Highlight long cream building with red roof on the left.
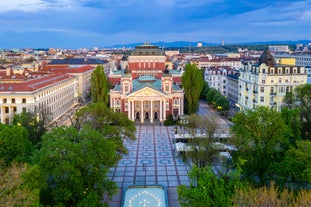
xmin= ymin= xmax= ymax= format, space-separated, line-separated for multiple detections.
xmin=0 ymin=74 xmax=78 ymax=124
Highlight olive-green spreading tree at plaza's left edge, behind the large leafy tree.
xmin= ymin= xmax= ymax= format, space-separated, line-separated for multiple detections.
xmin=76 ymin=103 xmax=136 ymax=154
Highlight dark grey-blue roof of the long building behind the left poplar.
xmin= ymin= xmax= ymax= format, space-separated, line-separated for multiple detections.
xmin=48 ymin=58 xmax=107 ymax=65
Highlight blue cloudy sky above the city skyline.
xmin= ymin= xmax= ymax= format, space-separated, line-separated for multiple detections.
xmin=0 ymin=0 xmax=311 ymax=48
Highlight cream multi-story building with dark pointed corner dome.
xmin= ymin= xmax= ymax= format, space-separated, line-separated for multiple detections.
xmin=238 ymin=49 xmax=307 ymax=111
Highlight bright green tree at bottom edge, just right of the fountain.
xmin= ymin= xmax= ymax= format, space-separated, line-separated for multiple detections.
xmin=177 ymin=166 xmax=239 ymax=207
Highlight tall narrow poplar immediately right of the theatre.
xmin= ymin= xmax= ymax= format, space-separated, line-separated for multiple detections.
xmin=181 ymin=64 xmax=204 ymax=114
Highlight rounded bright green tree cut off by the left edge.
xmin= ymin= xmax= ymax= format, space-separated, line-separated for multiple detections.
xmin=0 ymin=124 xmax=33 ymax=165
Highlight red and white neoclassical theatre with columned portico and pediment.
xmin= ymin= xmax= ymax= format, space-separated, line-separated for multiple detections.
xmin=108 ymin=43 xmax=184 ymax=123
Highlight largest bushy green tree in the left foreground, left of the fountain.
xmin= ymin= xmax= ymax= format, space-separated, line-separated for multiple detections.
xmin=25 ymin=127 xmax=120 ymax=207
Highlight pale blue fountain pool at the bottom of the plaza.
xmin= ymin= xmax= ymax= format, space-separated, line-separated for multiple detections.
xmin=121 ymin=185 xmax=168 ymax=207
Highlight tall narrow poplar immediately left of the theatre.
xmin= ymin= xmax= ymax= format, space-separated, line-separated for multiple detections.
xmin=91 ymin=65 xmax=110 ymax=106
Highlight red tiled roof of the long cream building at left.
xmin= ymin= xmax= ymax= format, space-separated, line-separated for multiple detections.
xmin=0 ymin=74 xmax=72 ymax=93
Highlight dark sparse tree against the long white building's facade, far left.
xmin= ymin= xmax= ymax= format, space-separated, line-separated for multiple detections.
xmin=13 ymin=112 xmax=46 ymax=145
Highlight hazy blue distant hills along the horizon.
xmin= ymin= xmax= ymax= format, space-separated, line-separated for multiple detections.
xmin=106 ymin=40 xmax=311 ymax=48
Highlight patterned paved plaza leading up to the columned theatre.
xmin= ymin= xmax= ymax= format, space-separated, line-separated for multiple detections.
xmin=109 ymin=125 xmax=189 ymax=207
